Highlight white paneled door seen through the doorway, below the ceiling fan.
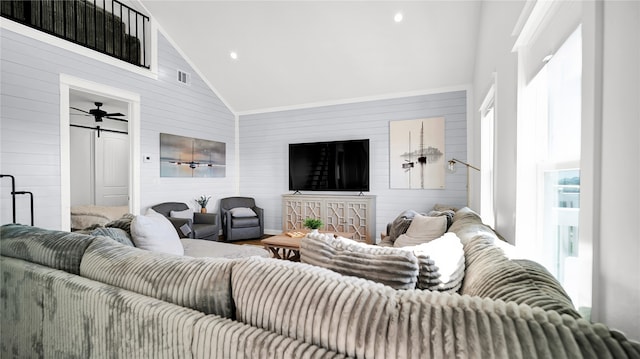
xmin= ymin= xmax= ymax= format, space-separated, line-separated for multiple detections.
xmin=95 ymin=132 xmax=130 ymax=206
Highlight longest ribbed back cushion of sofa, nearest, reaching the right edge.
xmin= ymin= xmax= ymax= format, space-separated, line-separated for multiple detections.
xmin=232 ymin=258 xmax=640 ymax=359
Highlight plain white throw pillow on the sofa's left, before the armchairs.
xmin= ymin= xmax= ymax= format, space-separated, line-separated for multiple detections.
xmin=131 ymin=209 xmax=184 ymax=256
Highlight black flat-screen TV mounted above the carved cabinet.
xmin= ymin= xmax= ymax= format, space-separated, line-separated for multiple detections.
xmin=289 ymin=139 xmax=369 ymax=192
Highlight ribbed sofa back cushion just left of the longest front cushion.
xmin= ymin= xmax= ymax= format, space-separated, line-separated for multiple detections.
xmin=80 ymin=237 xmax=234 ymax=318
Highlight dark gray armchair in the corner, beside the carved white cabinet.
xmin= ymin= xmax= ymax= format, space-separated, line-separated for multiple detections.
xmin=220 ymin=197 xmax=264 ymax=241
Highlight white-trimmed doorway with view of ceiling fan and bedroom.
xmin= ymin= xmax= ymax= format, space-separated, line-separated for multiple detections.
xmin=60 ymin=75 xmax=140 ymax=230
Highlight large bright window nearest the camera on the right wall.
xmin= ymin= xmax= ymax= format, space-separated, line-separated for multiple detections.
xmin=516 ymin=27 xmax=591 ymax=316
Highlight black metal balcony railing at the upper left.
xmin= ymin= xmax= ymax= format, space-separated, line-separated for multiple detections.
xmin=0 ymin=0 xmax=149 ymax=68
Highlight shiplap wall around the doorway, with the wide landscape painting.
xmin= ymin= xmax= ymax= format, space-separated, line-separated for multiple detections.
xmin=0 ymin=28 xmax=236 ymax=229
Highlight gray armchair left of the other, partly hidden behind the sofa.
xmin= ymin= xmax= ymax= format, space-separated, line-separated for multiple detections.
xmin=151 ymin=202 xmax=220 ymax=241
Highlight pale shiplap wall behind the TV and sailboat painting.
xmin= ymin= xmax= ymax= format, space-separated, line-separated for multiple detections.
xmin=239 ymin=91 xmax=467 ymax=237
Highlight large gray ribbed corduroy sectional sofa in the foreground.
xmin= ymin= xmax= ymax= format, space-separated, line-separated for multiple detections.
xmin=0 ymin=210 xmax=640 ymax=358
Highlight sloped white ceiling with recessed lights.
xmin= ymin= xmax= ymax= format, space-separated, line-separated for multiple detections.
xmin=141 ymin=0 xmax=482 ymax=113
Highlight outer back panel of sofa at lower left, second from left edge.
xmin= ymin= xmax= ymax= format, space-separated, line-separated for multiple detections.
xmin=42 ymin=271 xmax=204 ymax=359
